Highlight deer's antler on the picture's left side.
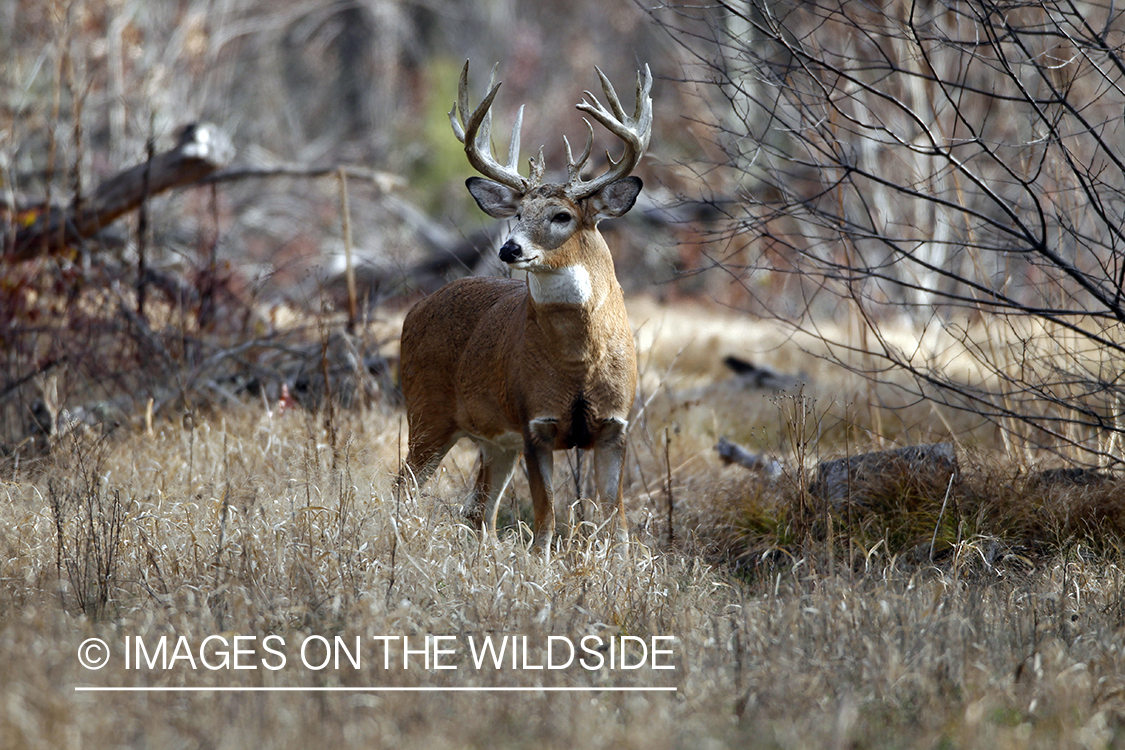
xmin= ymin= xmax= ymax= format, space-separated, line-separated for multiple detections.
xmin=449 ymin=61 xmax=543 ymax=193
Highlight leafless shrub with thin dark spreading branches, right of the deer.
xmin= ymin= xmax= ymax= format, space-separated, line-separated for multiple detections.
xmin=654 ymin=0 xmax=1125 ymax=467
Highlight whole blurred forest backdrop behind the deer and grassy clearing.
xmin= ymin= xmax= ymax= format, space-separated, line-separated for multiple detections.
xmin=0 ymin=0 xmax=1125 ymax=467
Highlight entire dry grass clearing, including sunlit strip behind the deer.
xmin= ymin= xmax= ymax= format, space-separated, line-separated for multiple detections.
xmin=0 ymin=306 xmax=1125 ymax=748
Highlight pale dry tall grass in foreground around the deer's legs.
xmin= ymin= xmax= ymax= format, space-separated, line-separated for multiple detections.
xmin=0 ymin=375 xmax=1125 ymax=748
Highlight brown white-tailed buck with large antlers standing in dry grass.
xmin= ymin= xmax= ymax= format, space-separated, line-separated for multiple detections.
xmin=398 ymin=62 xmax=653 ymax=554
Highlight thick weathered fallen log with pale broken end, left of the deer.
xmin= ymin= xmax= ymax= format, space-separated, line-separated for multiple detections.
xmin=3 ymin=123 xmax=234 ymax=262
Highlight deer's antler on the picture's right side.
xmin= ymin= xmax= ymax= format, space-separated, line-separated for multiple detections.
xmin=567 ymin=65 xmax=653 ymax=200
